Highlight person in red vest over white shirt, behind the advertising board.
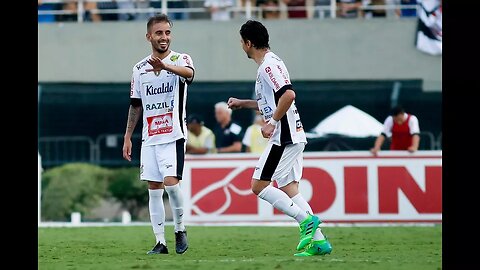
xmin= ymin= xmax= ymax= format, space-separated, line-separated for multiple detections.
xmin=370 ymin=106 xmax=420 ymax=155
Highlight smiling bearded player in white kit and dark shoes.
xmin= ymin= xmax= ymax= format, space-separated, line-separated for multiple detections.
xmin=123 ymin=14 xmax=194 ymax=254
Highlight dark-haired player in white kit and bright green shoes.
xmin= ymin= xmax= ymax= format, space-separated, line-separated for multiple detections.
xmin=228 ymin=20 xmax=332 ymax=256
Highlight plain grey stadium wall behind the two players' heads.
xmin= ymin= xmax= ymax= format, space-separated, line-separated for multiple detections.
xmin=38 ymin=19 xmax=442 ymax=91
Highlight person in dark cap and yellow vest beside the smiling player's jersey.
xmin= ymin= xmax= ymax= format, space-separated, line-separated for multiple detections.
xmin=187 ymin=114 xmax=216 ymax=154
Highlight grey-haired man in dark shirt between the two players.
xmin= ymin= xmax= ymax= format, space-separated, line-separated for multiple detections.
xmin=213 ymin=101 xmax=242 ymax=153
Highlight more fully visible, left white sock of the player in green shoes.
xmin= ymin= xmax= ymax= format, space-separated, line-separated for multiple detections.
xmin=258 ymin=185 xmax=307 ymax=223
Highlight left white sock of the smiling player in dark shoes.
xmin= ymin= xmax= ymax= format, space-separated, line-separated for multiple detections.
xmin=148 ymin=189 xmax=167 ymax=245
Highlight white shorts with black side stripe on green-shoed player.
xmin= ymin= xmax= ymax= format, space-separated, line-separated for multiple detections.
xmin=253 ymin=143 xmax=305 ymax=188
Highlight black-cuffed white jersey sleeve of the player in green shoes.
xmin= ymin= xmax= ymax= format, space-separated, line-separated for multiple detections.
xmin=260 ymin=64 xmax=293 ymax=99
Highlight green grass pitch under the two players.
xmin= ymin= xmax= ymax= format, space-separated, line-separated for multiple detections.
xmin=38 ymin=225 xmax=442 ymax=270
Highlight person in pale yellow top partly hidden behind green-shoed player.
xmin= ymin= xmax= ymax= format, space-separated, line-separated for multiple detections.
xmin=242 ymin=113 xmax=268 ymax=154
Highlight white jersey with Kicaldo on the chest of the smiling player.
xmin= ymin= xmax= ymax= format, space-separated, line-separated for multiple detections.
xmin=130 ymin=51 xmax=194 ymax=146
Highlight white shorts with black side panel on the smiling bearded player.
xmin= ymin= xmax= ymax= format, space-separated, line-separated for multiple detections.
xmin=140 ymin=139 xmax=186 ymax=183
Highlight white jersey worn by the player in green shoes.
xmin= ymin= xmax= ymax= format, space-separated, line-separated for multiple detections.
xmin=255 ymin=52 xmax=307 ymax=145
